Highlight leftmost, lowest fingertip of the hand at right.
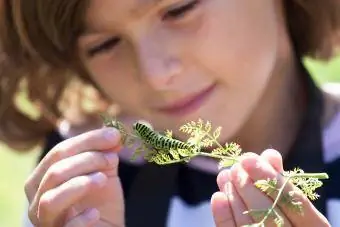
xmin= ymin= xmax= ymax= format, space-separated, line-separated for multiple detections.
xmin=211 ymin=192 xmax=236 ymax=227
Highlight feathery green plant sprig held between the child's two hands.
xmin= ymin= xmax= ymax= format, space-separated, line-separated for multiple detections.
xmin=103 ymin=117 xmax=329 ymax=226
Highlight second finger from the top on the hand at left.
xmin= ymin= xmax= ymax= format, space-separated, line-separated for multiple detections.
xmin=29 ymin=152 xmax=118 ymax=223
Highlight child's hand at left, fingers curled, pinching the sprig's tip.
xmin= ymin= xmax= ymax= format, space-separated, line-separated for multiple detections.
xmin=25 ymin=128 xmax=124 ymax=227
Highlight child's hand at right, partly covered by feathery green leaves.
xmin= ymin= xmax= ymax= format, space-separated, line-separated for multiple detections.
xmin=211 ymin=150 xmax=330 ymax=227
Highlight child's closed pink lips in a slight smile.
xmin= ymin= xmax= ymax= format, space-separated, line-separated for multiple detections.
xmin=159 ymin=83 xmax=216 ymax=115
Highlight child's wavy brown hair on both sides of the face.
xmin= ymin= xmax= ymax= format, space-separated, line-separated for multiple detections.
xmin=0 ymin=0 xmax=340 ymax=150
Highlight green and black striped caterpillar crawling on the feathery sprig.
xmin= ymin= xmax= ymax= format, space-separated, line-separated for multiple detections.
xmin=133 ymin=121 xmax=193 ymax=150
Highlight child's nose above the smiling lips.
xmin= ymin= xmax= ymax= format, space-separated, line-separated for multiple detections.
xmin=136 ymin=34 xmax=182 ymax=90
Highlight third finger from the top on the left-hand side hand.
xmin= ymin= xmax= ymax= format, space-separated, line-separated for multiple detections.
xmin=37 ymin=172 xmax=107 ymax=226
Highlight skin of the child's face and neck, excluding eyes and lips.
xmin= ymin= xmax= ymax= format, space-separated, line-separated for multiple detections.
xmin=78 ymin=0 xmax=298 ymax=152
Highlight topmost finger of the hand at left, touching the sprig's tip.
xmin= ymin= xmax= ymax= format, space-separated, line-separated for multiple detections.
xmin=25 ymin=128 xmax=121 ymax=202
